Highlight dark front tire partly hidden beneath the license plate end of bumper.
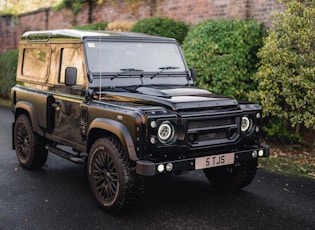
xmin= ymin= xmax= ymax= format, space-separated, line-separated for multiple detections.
xmin=204 ymin=159 xmax=258 ymax=190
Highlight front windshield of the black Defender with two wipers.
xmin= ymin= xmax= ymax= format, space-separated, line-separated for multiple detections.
xmin=86 ymin=41 xmax=186 ymax=73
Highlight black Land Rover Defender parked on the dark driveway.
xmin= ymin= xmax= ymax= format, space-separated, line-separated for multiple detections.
xmin=11 ymin=30 xmax=269 ymax=213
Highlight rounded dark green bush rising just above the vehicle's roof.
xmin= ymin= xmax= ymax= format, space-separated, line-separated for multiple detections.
xmin=131 ymin=17 xmax=188 ymax=43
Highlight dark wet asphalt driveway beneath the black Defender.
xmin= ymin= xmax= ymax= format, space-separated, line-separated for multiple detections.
xmin=0 ymin=107 xmax=315 ymax=230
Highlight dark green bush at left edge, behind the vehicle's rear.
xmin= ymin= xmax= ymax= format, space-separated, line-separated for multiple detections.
xmin=0 ymin=50 xmax=18 ymax=98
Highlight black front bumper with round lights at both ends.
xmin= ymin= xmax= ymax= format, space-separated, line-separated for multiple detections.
xmin=136 ymin=144 xmax=269 ymax=176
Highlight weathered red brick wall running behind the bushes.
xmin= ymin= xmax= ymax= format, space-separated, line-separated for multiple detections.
xmin=0 ymin=0 xmax=284 ymax=54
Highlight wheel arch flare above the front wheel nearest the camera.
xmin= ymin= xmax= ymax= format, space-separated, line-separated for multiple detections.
xmin=87 ymin=118 xmax=138 ymax=161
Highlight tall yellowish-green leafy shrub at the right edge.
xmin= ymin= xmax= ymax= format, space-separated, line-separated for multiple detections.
xmin=251 ymin=0 xmax=315 ymax=137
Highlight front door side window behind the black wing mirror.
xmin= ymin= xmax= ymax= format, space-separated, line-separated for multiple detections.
xmin=59 ymin=47 xmax=84 ymax=85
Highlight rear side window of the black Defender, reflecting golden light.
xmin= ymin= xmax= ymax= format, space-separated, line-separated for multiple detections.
xmin=22 ymin=48 xmax=51 ymax=82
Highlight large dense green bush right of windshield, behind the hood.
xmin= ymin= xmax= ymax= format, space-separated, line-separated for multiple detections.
xmin=183 ymin=20 xmax=263 ymax=99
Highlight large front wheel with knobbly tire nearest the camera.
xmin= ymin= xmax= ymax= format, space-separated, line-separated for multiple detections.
xmin=88 ymin=138 xmax=144 ymax=214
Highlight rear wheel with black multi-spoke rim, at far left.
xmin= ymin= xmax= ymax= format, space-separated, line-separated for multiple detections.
xmin=14 ymin=114 xmax=48 ymax=169
